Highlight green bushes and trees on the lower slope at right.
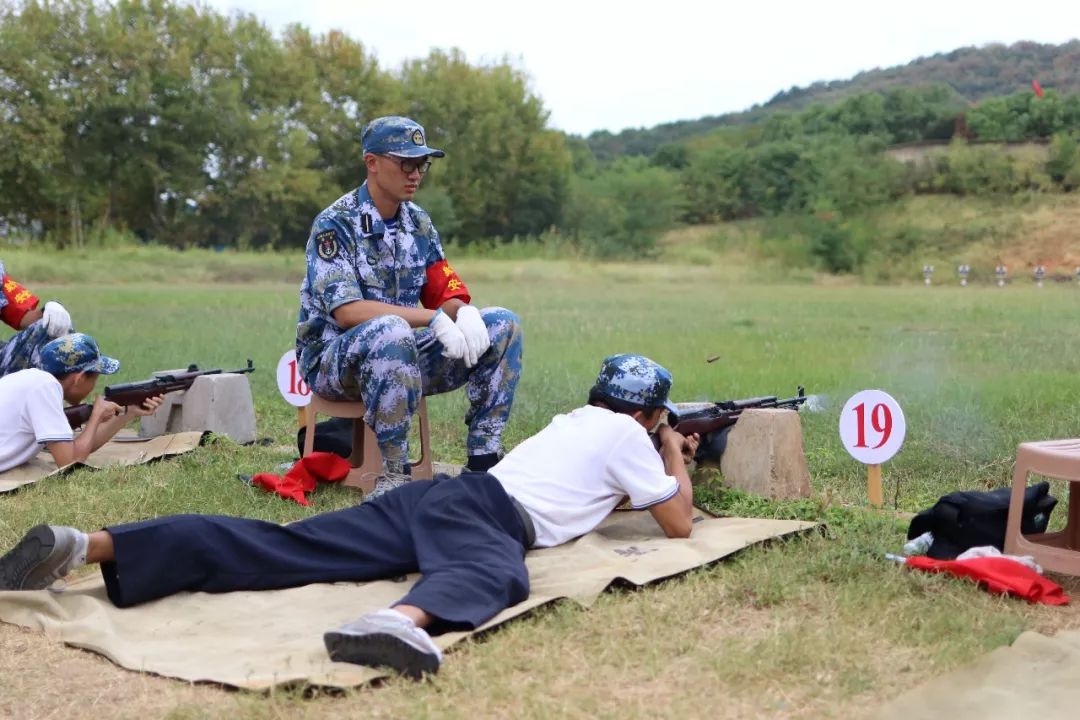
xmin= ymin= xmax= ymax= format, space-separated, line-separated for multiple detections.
xmin=570 ymin=85 xmax=1080 ymax=264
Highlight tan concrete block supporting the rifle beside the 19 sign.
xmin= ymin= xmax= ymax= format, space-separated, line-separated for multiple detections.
xmin=720 ymin=408 xmax=810 ymax=500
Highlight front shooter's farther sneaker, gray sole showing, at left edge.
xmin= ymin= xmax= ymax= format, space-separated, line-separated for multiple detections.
xmin=0 ymin=525 xmax=79 ymax=590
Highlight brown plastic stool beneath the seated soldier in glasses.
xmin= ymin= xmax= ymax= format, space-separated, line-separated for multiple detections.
xmin=303 ymin=393 xmax=432 ymax=492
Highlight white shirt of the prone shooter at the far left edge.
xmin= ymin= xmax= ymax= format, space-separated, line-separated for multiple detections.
xmin=0 ymin=369 xmax=75 ymax=473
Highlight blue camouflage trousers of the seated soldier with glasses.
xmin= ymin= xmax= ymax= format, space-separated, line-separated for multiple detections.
xmin=310 ymin=308 xmax=523 ymax=472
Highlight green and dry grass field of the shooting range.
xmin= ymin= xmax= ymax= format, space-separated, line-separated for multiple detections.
xmin=0 ymin=250 xmax=1080 ymax=718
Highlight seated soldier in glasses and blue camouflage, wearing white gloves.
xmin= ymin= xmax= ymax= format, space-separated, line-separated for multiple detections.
xmin=296 ymin=117 xmax=523 ymax=494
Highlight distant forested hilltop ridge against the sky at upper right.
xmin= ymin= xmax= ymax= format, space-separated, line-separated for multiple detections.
xmin=586 ymin=40 xmax=1080 ymax=161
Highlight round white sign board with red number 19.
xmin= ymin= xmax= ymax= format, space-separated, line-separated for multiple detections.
xmin=840 ymin=390 xmax=907 ymax=465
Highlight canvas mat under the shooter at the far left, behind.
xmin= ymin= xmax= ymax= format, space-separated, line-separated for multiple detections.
xmin=0 ymin=432 xmax=202 ymax=492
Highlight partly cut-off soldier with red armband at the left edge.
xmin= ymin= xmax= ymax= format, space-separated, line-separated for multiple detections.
xmin=0 ymin=260 xmax=71 ymax=377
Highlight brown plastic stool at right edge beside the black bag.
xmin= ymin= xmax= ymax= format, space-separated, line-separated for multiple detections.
xmin=1005 ymin=439 xmax=1080 ymax=575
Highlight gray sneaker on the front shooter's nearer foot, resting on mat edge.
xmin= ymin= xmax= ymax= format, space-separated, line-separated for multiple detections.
xmin=323 ymin=610 xmax=443 ymax=680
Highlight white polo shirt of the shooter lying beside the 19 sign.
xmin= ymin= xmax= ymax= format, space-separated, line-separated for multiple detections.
xmin=488 ymin=406 xmax=678 ymax=547
